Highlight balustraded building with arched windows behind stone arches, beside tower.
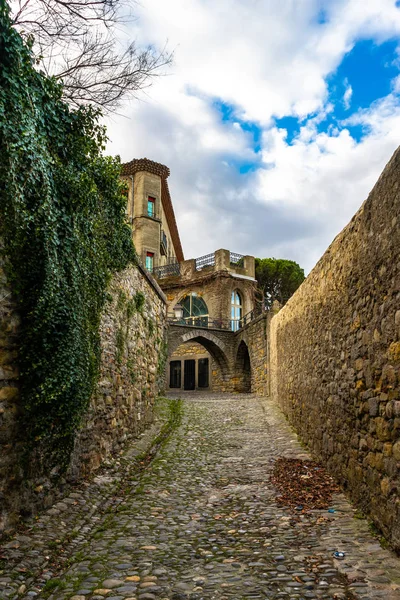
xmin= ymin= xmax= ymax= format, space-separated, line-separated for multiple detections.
xmin=155 ymin=249 xmax=257 ymax=390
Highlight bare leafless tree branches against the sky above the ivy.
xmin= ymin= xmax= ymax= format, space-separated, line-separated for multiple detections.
xmin=12 ymin=0 xmax=172 ymax=113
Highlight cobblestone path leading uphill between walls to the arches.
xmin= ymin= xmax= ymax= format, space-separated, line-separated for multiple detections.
xmin=0 ymin=394 xmax=400 ymax=600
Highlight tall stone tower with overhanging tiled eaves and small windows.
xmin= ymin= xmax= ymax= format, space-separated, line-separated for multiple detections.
xmin=122 ymin=158 xmax=183 ymax=272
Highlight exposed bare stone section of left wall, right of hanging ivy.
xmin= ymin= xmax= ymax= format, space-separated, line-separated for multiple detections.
xmin=69 ymin=266 xmax=167 ymax=477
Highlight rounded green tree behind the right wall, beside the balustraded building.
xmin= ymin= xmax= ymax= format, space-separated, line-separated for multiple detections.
xmin=256 ymin=258 xmax=305 ymax=308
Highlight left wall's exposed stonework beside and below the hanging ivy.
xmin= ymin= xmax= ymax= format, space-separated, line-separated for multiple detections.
xmin=0 ymin=266 xmax=167 ymax=531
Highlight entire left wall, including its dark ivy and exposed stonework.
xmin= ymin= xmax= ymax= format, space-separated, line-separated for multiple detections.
xmin=0 ymin=8 xmax=165 ymax=529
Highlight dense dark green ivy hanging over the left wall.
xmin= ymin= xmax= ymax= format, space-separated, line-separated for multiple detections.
xmin=0 ymin=0 xmax=135 ymax=470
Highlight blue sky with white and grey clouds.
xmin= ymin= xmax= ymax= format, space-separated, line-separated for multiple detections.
xmin=108 ymin=0 xmax=400 ymax=272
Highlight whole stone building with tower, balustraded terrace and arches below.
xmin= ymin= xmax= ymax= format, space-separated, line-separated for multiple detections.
xmin=122 ymin=158 xmax=257 ymax=391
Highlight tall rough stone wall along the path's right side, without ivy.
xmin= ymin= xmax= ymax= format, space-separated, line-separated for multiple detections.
xmin=270 ymin=151 xmax=400 ymax=549
